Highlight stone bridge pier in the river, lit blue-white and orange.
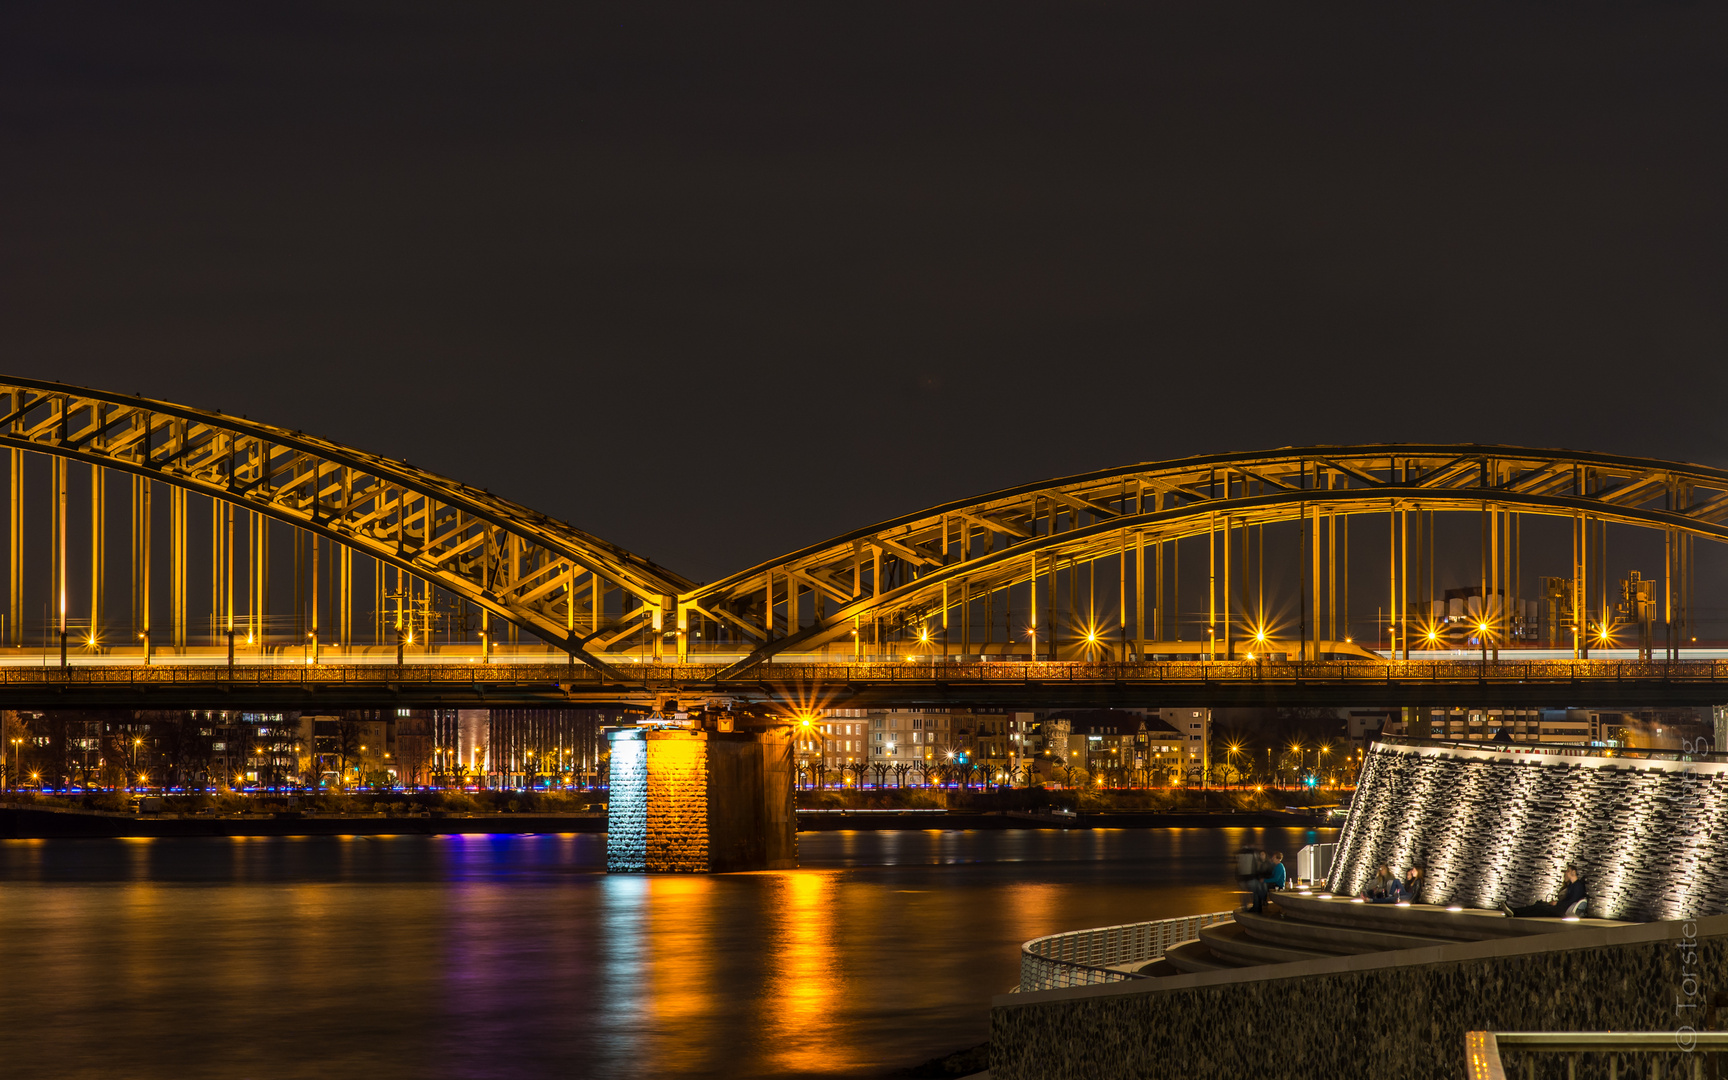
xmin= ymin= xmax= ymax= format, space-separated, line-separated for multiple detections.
xmin=607 ymin=727 xmax=798 ymax=874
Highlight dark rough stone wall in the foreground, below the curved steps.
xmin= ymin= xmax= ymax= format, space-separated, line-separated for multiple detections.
xmin=990 ymin=916 xmax=1728 ymax=1080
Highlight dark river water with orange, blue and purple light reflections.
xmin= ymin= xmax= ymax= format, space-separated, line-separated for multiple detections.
xmin=0 ymin=829 xmax=1331 ymax=1078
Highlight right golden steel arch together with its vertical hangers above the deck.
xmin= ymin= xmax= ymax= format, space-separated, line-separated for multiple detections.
xmin=679 ymin=446 xmax=1728 ymax=674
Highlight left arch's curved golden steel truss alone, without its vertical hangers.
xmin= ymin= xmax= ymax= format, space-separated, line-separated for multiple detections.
xmin=0 ymin=378 xmax=693 ymax=667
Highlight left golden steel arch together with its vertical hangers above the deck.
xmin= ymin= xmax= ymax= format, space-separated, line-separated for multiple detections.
xmin=0 ymin=378 xmax=691 ymax=665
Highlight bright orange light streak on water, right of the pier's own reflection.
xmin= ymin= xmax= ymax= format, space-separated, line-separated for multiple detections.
xmin=762 ymin=871 xmax=842 ymax=1075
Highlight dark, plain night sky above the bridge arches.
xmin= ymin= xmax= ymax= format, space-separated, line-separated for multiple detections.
xmin=0 ymin=0 xmax=1728 ymax=579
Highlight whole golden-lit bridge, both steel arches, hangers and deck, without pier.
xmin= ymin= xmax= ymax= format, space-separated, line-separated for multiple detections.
xmin=0 ymin=378 xmax=1728 ymax=708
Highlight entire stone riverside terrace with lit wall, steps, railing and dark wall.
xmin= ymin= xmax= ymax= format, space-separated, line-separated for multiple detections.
xmin=990 ymin=740 xmax=1728 ymax=1080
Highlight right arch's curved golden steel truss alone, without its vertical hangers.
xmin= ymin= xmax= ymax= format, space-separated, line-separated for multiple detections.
xmin=694 ymin=444 xmax=1728 ymax=676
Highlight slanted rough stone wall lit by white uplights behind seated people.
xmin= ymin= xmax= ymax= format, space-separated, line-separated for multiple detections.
xmin=1329 ymin=743 xmax=1728 ymax=921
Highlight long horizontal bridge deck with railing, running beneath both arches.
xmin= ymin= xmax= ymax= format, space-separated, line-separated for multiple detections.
xmin=0 ymin=658 xmax=1728 ymax=719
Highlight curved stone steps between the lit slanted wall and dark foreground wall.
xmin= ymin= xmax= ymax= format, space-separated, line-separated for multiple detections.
xmin=1139 ymin=890 xmax=1626 ymax=975
